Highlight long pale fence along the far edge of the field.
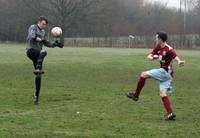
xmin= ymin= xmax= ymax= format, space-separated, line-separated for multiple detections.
xmin=65 ymin=34 xmax=200 ymax=48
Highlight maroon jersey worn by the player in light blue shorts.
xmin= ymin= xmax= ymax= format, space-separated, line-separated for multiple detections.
xmin=151 ymin=44 xmax=177 ymax=77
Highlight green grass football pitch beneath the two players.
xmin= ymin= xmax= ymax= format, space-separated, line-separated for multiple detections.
xmin=0 ymin=44 xmax=200 ymax=138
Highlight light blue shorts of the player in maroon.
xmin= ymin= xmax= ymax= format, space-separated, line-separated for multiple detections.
xmin=147 ymin=68 xmax=174 ymax=93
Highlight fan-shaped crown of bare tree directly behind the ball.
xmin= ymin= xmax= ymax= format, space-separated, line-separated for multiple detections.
xmin=22 ymin=0 xmax=100 ymax=33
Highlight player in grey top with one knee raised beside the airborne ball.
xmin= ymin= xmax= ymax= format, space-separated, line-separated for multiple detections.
xmin=26 ymin=16 xmax=64 ymax=104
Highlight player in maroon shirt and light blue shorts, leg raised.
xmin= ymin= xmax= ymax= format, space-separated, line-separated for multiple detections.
xmin=126 ymin=32 xmax=186 ymax=120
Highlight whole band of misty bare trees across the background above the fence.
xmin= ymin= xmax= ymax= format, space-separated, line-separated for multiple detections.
xmin=0 ymin=0 xmax=200 ymax=42
